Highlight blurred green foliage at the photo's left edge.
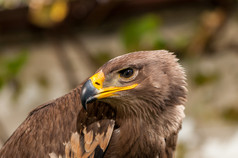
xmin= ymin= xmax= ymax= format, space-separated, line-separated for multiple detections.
xmin=0 ymin=50 xmax=28 ymax=89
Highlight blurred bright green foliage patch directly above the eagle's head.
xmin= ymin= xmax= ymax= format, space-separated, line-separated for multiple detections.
xmin=121 ymin=14 xmax=165 ymax=51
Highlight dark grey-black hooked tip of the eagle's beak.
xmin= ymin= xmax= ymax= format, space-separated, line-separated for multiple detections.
xmin=80 ymin=80 xmax=97 ymax=110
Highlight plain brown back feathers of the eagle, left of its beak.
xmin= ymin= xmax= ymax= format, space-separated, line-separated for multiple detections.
xmin=0 ymin=87 xmax=81 ymax=158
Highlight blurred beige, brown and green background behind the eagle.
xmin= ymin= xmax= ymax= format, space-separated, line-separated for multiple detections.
xmin=0 ymin=0 xmax=238 ymax=158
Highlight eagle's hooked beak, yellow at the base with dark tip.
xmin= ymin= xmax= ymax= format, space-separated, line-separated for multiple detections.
xmin=81 ymin=70 xmax=138 ymax=109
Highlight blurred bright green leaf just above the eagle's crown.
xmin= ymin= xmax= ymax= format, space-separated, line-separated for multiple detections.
xmin=121 ymin=14 xmax=160 ymax=50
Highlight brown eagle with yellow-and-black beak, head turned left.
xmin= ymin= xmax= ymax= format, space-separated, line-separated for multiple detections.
xmin=0 ymin=50 xmax=187 ymax=158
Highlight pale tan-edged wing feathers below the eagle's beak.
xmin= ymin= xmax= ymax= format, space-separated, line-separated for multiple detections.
xmin=65 ymin=120 xmax=114 ymax=158
